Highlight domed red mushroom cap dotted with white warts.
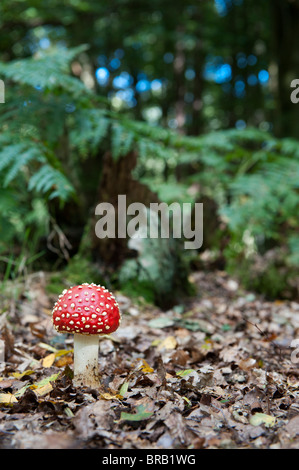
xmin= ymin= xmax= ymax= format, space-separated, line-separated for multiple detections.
xmin=52 ymin=283 xmax=121 ymax=335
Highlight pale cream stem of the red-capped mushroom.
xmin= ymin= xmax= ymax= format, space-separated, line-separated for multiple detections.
xmin=73 ymin=333 xmax=99 ymax=388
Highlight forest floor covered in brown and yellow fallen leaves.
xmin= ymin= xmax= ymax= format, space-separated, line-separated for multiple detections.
xmin=0 ymin=272 xmax=299 ymax=449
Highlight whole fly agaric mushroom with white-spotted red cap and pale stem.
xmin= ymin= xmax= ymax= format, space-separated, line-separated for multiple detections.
xmin=52 ymin=283 xmax=121 ymax=387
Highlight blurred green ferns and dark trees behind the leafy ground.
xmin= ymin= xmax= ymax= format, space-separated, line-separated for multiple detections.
xmin=0 ymin=0 xmax=299 ymax=305
